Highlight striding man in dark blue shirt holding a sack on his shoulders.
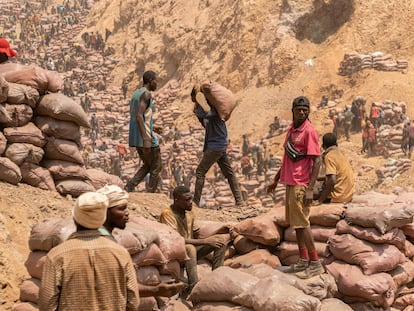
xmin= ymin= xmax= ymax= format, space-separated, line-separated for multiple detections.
xmin=191 ymin=85 xmax=243 ymax=206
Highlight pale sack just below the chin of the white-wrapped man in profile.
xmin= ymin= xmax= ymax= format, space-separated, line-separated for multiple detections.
xmin=112 ymin=222 xmax=160 ymax=255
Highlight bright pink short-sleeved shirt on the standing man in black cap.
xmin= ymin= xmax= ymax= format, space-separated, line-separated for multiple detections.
xmin=280 ymin=120 xmax=321 ymax=186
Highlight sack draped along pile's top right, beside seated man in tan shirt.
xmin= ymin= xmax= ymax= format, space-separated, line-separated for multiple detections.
xmin=130 ymin=216 xmax=188 ymax=262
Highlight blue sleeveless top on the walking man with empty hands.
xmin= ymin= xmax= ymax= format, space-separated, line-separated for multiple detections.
xmin=128 ymin=87 xmax=159 ymax=147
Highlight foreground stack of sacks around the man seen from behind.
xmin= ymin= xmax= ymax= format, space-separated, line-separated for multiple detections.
xmin=20 ymin=217 xmax=187 ymax=311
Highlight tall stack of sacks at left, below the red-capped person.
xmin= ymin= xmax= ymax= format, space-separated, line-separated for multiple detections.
xmin=0 ymin=63 xmax=122 ymax=197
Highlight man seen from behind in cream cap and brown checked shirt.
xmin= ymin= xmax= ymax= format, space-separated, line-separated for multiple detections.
xmin=39 ymin=192 xmax=139 ymax=311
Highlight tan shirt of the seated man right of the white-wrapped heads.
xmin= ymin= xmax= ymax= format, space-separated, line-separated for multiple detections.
xmin=160 ymin=207 xmax=199 ymax=239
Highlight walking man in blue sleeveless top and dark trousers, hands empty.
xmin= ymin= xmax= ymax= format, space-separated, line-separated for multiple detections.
xmin=125 ymin=71 xmax=162 ymax=192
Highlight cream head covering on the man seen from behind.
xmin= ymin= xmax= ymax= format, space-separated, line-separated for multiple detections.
xmin=72 ymin=192 xmax=108 ymax=229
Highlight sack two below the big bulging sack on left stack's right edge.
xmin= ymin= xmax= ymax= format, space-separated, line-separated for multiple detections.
xmin=44 ymin=137 xmax=83 ymax=165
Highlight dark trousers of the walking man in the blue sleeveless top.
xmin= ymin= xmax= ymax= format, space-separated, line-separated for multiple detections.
xmin=126 ymin=147 xmax=162 ymax=192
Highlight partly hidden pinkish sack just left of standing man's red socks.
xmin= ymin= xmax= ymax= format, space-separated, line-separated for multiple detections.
xmin=224 ymin=249 xmax=281 ymax=269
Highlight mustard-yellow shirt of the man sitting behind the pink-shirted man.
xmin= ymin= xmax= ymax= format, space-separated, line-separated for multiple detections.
xmin=323 ymin=146 xmax=355 ymax=203
